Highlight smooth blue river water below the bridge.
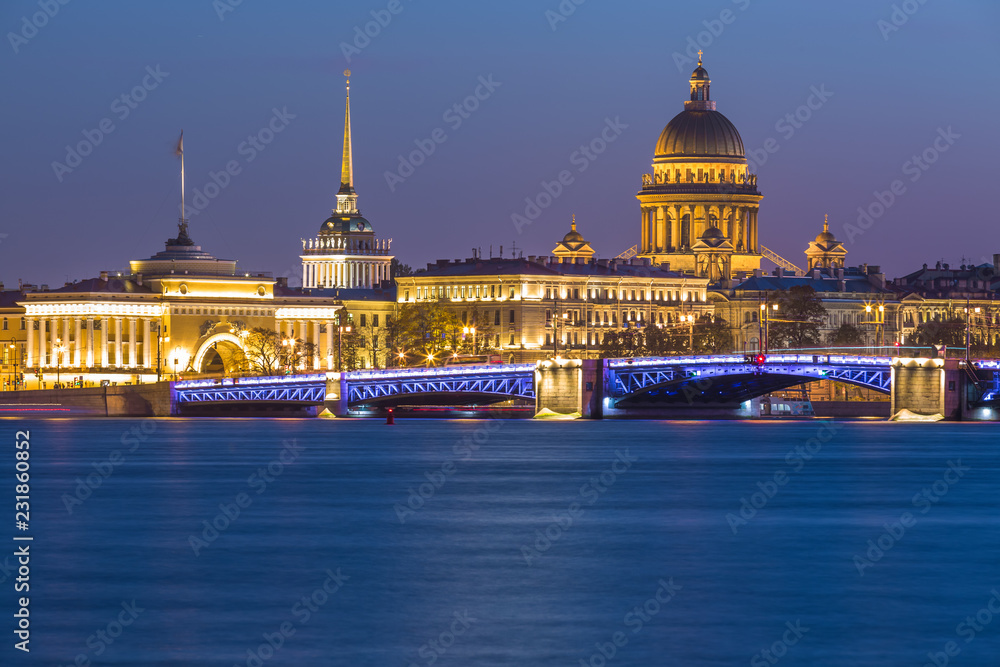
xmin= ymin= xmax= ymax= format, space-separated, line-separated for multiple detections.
xmin=0 ymin=419 xmax=1000 ymax=667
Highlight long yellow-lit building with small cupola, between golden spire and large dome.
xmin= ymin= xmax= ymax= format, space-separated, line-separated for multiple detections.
xmin=396 ymin=223 xmax=712 ymax=362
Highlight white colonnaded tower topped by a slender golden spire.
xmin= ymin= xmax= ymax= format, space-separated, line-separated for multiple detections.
xmin=301 ymin=70 xmax=392 ymax=289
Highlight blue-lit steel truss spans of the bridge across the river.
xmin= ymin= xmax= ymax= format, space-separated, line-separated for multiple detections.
xmin=173 ymin=354 xmax=1000 ymax=413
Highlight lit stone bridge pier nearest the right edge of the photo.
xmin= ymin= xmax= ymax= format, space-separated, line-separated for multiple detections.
xmin=891 ymin=357 xmax=965 ymax=421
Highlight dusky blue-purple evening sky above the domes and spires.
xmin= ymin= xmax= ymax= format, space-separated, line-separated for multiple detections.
xmin=0 ymin=0 xmax=1000 ymax=288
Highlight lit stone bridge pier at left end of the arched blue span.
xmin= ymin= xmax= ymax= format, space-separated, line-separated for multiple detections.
xmin=535 ymin=357 xmax=604 ymax=419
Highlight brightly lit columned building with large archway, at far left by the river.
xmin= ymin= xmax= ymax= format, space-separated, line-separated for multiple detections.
xmin=6 ymin=221 xmax=395 ymax=388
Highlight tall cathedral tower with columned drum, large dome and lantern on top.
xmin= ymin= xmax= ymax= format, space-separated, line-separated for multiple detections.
xmin=636 ymin=52 xmax=763 ymax=280
